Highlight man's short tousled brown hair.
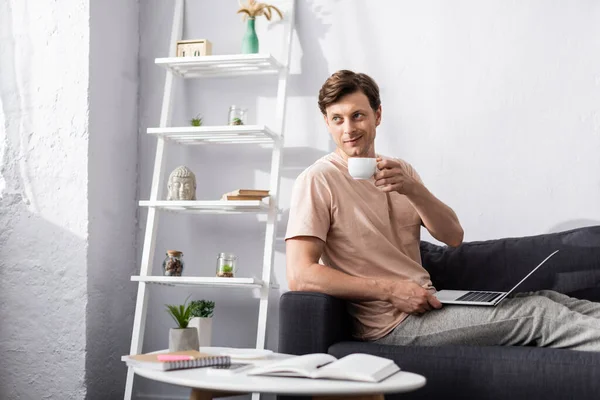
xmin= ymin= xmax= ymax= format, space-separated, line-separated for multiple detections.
xmin=319 ymin=69 xmax=381 ymax=115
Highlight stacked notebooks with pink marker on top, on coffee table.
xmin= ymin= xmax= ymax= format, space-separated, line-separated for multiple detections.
xmin=121 ymin=350 xmax=231 ymax=371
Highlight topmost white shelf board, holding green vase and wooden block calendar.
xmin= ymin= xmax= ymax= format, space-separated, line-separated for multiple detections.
xmin=154 ymin=54 xmax=284 ymax=78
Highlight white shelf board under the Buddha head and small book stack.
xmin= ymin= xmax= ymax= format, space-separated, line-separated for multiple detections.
xmin=139 ymin=200 xmax=269 ymax=214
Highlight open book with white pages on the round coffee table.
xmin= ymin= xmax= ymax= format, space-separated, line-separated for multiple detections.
xmin=247 ymin=353 xmax=400 ymax=382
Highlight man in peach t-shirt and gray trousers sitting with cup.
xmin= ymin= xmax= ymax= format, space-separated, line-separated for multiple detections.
xmin=286 ymin=70 xmax=600 ymax=350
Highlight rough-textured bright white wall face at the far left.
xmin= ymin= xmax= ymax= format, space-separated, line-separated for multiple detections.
xmin=0 ymin=0 xmax=89 ymax=399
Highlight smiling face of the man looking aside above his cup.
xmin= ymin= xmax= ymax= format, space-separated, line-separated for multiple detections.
xmin=324 ymin=91 xmax=381 ymax=159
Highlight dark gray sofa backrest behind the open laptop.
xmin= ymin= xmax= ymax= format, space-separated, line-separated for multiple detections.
xmin=421 ymin=226 xmax=600 ymax=293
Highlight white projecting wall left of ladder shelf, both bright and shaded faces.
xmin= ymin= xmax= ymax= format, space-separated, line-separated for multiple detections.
xmin=0 ymin=0 xmax=139 ymax=399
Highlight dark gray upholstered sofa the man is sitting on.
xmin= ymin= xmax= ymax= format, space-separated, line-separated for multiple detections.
xmin=279 ymin=226 xmax=600 ymax=400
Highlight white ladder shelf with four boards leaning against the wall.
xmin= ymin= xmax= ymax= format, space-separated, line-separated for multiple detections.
xmin=124 ymin=0 xmax=295 ymax=400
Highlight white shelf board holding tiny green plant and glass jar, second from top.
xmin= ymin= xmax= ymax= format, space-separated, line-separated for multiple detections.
xmin=146 ymin=125 xmax=281 ymax=145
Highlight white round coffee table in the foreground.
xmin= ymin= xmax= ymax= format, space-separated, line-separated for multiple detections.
xmin=134 ymin=348 xmax=426 ymax=399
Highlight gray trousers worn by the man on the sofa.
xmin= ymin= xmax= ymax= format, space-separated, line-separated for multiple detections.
xmin=375 ymin=290 xmax=600 ymax=351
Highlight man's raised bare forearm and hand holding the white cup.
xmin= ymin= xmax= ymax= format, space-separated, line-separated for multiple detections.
xmin=375 ymin=158 xmax=464 ymax=247
